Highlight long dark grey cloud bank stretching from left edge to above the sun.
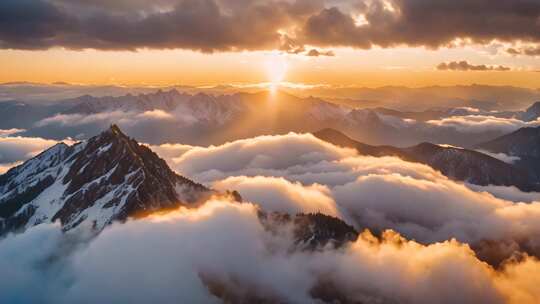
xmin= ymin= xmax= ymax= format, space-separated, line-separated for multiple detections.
xmin=0 ymin=0 xmax=309 ymax=52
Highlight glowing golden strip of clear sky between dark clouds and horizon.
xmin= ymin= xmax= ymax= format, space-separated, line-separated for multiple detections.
xmin=0 ymin=48 xmax=540 ymax=89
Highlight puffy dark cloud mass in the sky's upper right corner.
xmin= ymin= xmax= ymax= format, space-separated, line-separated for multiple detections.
xmin=304 ymin=0 xmax=540 ymax=48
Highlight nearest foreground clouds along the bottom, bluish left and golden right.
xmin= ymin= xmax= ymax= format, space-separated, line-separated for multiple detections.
xmin=0 ymin=201 xmax=540 ymax=304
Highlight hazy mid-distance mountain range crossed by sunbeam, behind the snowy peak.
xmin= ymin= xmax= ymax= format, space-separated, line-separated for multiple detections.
xmin=0 ymin=90 xmax=540 ymax=148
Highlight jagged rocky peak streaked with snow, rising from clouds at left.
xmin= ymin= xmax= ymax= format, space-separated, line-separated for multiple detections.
xmin=0 ymin=125 xmax=212 ymax=234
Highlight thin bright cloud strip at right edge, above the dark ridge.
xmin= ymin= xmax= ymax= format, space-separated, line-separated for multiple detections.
xmin=427 ymin=115 xmax=540 ymax=133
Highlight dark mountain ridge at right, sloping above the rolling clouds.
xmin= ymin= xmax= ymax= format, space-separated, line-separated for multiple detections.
xmin=314 ymin=129 xmax=540 ymax=191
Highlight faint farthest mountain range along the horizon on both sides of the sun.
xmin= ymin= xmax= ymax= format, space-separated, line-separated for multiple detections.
xmin=0 ymin=82 xmax=540 ymax=112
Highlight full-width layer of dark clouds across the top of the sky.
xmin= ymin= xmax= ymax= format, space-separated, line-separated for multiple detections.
xmin=0 ymin=0 xmax=540 ymax=53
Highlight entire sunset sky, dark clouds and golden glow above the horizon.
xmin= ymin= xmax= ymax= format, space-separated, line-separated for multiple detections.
xmin=0 ymin=0 xmax=540 ymax=88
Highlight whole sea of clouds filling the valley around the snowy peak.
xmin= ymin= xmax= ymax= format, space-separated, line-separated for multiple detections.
xmin=0 ymin=133 xmax=540 ymax=303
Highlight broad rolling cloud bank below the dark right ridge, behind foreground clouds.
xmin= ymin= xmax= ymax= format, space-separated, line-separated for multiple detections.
xmin=156 ymin=133 xmax=540 ymax=256
